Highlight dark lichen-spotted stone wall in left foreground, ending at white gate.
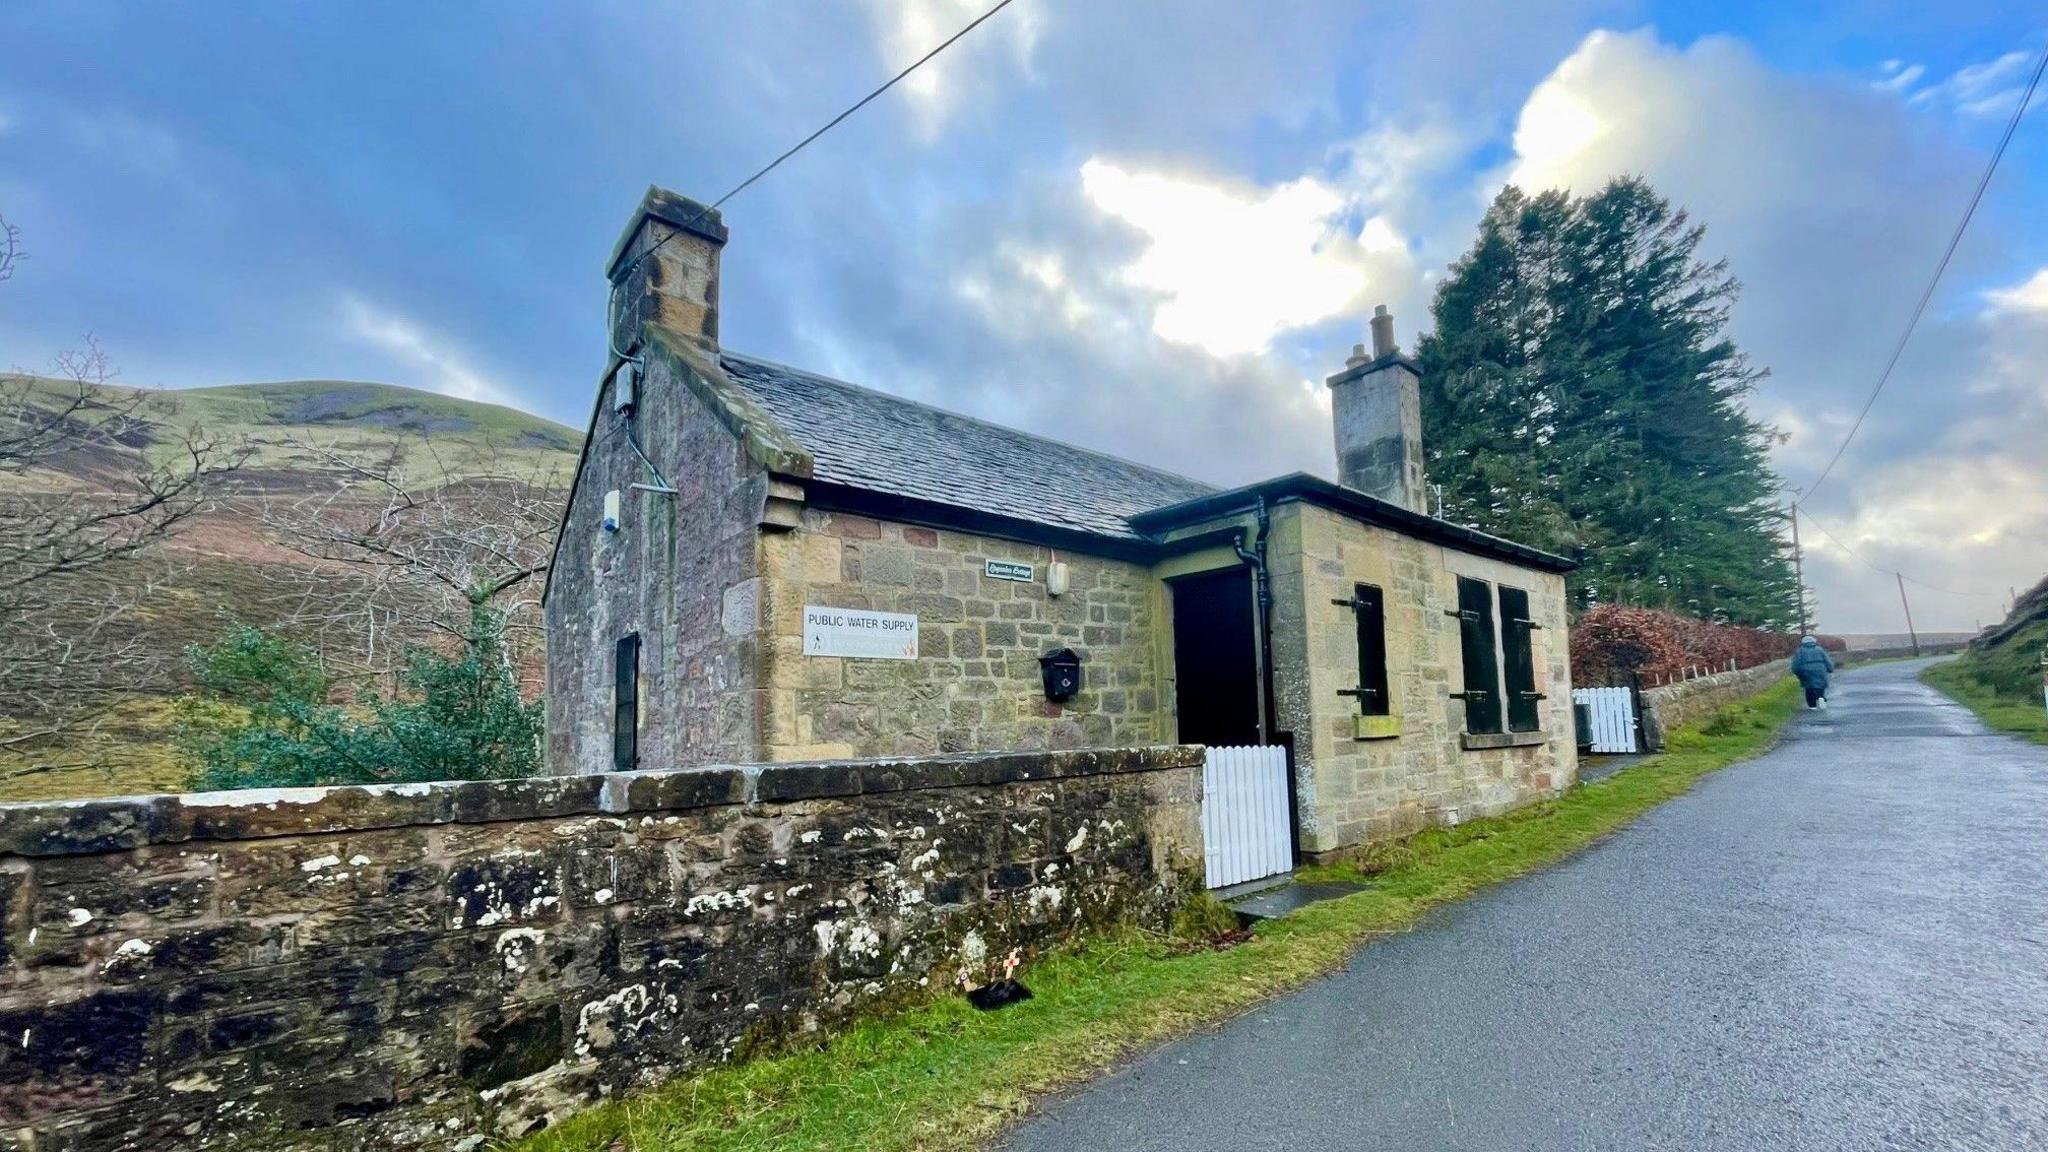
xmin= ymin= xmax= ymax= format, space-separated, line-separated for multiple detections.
xmin=0 ymin=746 xmax=1200 ymax=1152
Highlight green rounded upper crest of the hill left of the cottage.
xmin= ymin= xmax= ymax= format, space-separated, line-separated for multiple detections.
xmin=0 ymin=377 xmax=584 ymax=490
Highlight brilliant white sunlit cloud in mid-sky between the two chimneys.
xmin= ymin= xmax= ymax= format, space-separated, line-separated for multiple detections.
xmin=1081 ymin=158 xmax=1413 ymax=357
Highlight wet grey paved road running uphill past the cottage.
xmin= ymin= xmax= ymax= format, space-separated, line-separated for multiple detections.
xmin=1012 ymin=664 xmax=2048 ymax=1152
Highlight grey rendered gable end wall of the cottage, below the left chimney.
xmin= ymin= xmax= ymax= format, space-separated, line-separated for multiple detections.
xmin=545 ymin=342 xmax=768 ymax=773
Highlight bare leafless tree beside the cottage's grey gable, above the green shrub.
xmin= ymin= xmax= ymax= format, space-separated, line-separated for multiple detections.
xmin=260 ymin=437 xmax=567 ymax=687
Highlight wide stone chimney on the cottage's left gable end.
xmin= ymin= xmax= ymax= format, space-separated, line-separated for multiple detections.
xmin=604 ymin=187 xmax=725 ymax=353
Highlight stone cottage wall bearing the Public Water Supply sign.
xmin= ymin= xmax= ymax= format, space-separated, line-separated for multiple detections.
xmin=760 ymin=508 xmax=1174 ymax=760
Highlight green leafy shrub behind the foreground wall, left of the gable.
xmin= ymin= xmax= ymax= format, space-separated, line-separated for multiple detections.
xmin=178 ymin=605 xmax=543 ymax=789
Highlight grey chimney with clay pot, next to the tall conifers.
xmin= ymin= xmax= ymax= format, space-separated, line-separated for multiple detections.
xmin=1329 ymin=303 xmax=1430 ymax=515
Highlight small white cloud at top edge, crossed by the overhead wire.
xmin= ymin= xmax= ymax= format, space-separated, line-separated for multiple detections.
xmin=868 ymin=0 xmax=1042 ymax=137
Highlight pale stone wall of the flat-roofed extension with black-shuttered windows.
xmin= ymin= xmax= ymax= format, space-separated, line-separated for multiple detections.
xmin=1268 ymin=504 xmax=1577 ymax=853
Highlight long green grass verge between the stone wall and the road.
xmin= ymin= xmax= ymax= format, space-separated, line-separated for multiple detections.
xmin=516 ymin=681 xmax=1798 ymax=1152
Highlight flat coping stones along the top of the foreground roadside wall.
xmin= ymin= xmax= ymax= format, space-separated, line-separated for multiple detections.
xmin=0 ymin=744 xmax=1202 ymax=857
